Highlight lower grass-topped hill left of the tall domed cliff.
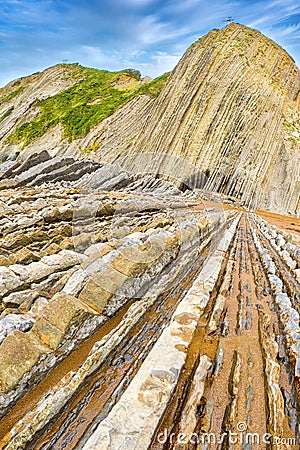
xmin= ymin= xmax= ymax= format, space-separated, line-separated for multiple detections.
xmin=0 ymin=64 xmax=158 ymax=162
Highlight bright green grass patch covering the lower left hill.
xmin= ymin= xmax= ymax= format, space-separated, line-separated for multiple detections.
xmin=7 ymin=65 xmax=169 ymax=147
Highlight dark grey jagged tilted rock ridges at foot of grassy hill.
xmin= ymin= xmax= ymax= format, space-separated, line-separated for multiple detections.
xmin=0 ymin=150 xmax=192 ymax=197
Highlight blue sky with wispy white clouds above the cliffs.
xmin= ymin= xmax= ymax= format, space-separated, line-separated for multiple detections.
xmin=0 ymin=0 xmax=300 ymax=86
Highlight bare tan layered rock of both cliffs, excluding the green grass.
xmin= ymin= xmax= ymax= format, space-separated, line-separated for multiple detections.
xmin=0 ymin=24 xmax=300 ymax=213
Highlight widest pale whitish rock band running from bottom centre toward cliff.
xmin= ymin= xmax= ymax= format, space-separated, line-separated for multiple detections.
xmin=84 ymin=214 xmax=239 ymax=450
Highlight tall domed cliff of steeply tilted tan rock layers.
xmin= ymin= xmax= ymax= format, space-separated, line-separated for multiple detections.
xmin=126 ymin=24 xmax=300 ymax=212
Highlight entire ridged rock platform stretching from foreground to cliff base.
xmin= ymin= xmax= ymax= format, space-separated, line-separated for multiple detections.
xmin=0 ymin=152 xmax=300 ymax=450
